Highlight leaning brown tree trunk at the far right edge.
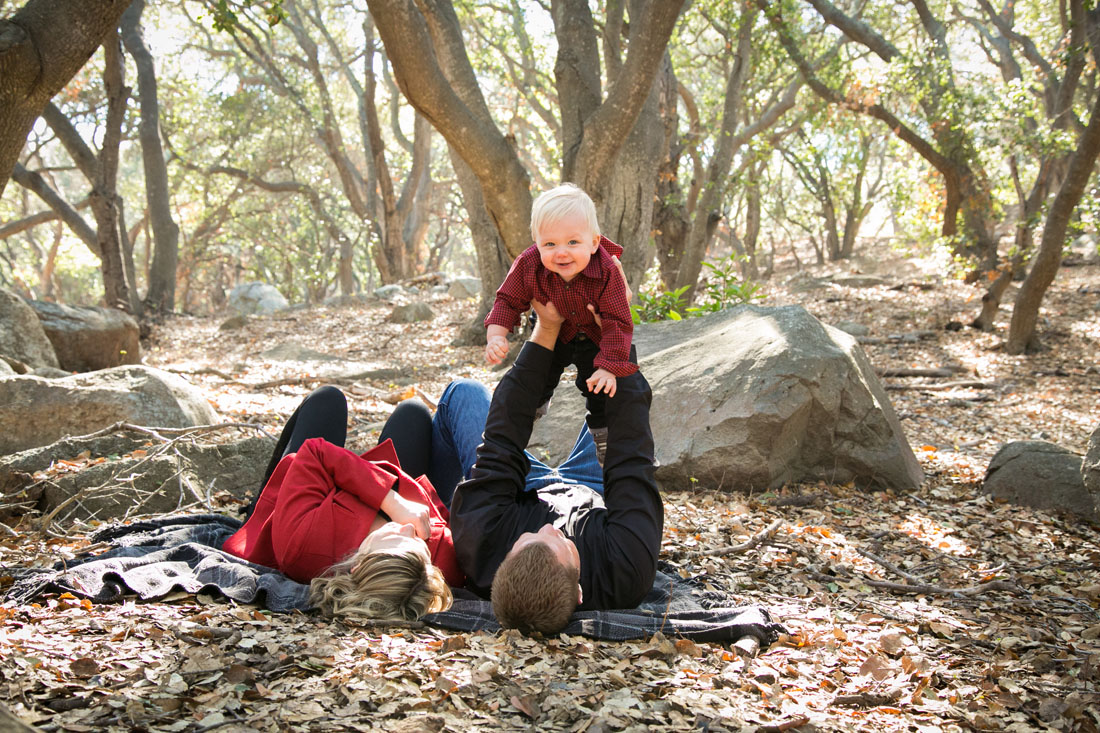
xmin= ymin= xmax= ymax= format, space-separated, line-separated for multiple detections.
xmin=1005 ymin=85 xmax=1100 ymax=353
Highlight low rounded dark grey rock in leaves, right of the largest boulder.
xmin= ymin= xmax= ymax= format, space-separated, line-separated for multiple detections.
xmin=983 ymin=440 xmax=1100 ymax=522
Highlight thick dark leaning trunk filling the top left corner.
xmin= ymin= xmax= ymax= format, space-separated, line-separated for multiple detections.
xmin=0 ymin=0 xmax=130 ymax=194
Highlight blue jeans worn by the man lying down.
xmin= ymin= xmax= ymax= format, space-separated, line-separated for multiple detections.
xmin=428 ymin=380 xmax=604 ymax=506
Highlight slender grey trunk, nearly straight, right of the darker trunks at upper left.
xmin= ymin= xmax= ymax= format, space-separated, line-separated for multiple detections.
xmin=121 ymin=0 xmax=179 ymax=311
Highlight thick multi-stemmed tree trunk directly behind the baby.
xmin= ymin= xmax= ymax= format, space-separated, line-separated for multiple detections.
xmin=367 ymin=0 xmax=683 ymax=306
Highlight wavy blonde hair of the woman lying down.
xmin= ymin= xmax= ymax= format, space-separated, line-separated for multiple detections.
xmin=309 ymin=551 xmax=453 ymax=622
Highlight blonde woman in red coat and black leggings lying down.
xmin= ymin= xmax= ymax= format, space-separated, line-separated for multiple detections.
xmin=222 ymin=386 xmax=470 ymax=621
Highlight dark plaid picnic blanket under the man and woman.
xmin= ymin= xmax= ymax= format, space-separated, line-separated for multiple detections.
xmin=4 ymin=514 xmax=784 ymax=648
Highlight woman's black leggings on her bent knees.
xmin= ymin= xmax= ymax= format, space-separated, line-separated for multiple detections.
xmin=245 ymin=385 xmax=431 ymax=518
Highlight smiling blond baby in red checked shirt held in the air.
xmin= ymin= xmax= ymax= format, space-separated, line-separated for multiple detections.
xmin=485 ymin=184 xmax=638 ymax=466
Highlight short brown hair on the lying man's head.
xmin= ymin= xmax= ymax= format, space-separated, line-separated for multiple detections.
xmin=492 ymin=543 xmax=580 ymax=634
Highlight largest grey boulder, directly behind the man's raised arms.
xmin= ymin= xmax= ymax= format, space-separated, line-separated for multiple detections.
xmin=531 ymin=306 xmax=923 ymax=491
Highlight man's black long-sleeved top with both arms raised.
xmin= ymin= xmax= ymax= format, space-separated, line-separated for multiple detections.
xmin=451 ymin=342 xmax=664 ymax=610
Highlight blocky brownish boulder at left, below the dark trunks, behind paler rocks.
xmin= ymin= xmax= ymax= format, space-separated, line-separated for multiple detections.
xmin=31 ymin=300 xmax=141 ymax=372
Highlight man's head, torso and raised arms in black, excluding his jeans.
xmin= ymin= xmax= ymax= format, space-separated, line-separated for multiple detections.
xmin=451 ymin=302 xmax=664 ymax=634
